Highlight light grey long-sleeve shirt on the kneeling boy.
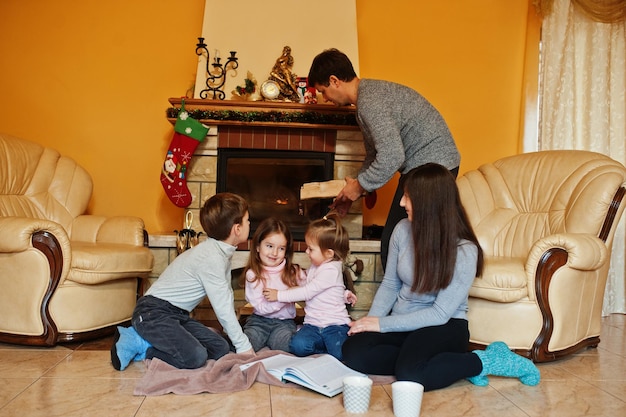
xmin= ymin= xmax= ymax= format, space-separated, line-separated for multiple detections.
xmin=146 ymin=238 xmax=252 ymax=353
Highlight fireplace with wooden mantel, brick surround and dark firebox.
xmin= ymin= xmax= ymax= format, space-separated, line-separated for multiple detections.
xmin=166 ymin=98 xmax=365 ymax=240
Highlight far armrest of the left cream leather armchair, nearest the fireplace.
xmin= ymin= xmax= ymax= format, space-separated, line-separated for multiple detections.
xmin=71 ymin=214 xmax=145 ymax=246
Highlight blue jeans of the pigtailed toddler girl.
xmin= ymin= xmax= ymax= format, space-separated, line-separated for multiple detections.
xmin=289 ymin=324 xmax=350 ymax=360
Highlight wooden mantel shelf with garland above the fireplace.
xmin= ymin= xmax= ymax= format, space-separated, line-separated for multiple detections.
xmin=167 ymin=98 xmax=359 ymax=130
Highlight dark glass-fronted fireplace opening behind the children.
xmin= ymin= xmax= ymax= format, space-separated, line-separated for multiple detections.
xmin=217 ymin=148 xmax=334 ymax=240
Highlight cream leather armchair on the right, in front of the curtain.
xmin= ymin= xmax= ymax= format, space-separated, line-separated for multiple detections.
xmin=457 ymin=151 xmax=626 ymax=362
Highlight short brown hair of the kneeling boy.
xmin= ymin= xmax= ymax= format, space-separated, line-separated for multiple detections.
xmin=200 ymin=193 xmax=248 ymax=240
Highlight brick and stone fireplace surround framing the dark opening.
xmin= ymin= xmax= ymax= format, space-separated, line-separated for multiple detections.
xmin=149 ymin=99 xmax=382 ymax=325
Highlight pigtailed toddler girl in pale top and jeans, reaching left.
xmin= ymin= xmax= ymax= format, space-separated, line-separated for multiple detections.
xmin=263 ymin=214 xmax=356 ymax=360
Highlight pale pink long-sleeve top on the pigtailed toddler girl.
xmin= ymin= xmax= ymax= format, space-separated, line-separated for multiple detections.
xmin=277 ymin=261 xmax=350 ymax=328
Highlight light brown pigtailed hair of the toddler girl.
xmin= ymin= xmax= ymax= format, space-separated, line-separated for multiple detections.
xmin=305 ymin=212 xmax=355 ymax=293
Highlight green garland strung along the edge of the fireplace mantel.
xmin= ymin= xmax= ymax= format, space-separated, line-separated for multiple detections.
xmin=166 ymin=107 xmax=357 ymax=126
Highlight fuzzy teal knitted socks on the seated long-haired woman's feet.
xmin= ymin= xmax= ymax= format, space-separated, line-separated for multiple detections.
xmin=467 ymin=342 xmax=541 ymax=387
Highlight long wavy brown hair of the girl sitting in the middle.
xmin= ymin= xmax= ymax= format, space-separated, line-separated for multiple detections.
xmin=242 ymin=217 xmax=300 ymax=287
